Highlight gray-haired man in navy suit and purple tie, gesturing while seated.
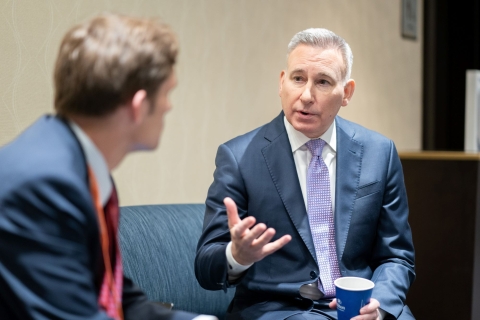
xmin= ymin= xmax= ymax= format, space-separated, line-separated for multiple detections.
xmin=195 ymin=29 xmax=415 ymax=320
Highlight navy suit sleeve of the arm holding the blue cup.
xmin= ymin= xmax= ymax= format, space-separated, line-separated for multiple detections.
xmin=371 ymin=142 xmax=415 ymax=317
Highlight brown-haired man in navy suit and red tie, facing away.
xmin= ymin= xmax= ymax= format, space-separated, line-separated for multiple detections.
xmin=0 ymin=15 xmax=211 ymax=320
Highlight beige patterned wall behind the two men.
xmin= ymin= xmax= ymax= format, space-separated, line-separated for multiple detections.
xmin=0 ymin=0 xmax=423 ymax=205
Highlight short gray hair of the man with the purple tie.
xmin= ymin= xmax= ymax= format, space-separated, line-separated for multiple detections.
xmin=287 ymin=28 xmax=353 ymax=85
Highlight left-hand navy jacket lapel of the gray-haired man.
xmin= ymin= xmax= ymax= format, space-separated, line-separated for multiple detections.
xmin=262 ymin=112 xmax=317 ymax=261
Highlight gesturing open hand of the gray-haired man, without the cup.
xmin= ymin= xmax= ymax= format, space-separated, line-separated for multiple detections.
xmin=223 ymin=197 xmax=292 ymax=266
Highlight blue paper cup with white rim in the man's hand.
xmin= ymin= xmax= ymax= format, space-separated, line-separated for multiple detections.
xmin=334 ymin=277 xmax=375 ymax=320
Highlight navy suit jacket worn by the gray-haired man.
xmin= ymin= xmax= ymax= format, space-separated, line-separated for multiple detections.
xmin=195 ymin=112 xmax=415 ymax=319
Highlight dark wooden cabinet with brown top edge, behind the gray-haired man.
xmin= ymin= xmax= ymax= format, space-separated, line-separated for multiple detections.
xmin=400 ymin=152 xmax=480 ymax=320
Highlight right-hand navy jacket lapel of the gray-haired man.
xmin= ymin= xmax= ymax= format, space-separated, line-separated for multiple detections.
xmin=335 ymin=117 xmax=363 ymax=265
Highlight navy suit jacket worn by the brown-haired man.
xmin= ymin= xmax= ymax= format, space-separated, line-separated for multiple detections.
xmin=0 ymin=116 xmax=195 ymax=320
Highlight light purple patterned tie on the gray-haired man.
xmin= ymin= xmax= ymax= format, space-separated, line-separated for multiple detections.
xmin=305 ymin=139 xmax=341 ymax=298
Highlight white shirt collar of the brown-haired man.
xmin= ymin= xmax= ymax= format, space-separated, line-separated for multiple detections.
xmin=68 ymin=121 xmax=113 ymax=206
